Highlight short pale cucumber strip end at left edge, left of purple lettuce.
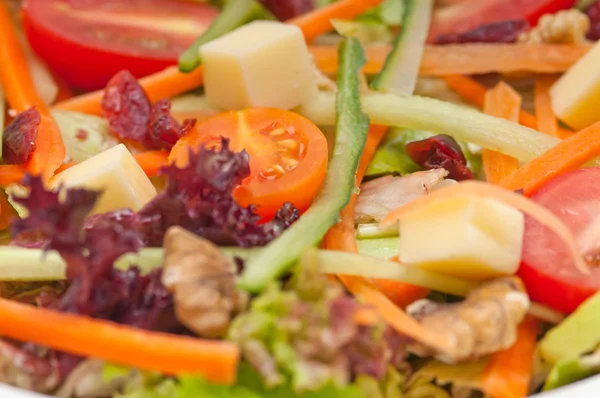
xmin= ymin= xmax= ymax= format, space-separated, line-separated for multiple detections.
xmin=0 ymin=246 xmax=67 ymax=282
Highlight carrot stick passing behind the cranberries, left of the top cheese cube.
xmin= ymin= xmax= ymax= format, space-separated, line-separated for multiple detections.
xmin=53 ymin=66 xmax=203 ymax=115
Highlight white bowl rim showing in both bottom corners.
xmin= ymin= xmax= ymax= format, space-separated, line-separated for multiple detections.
xmin=0 ymin=375 xmax=600 ymax=398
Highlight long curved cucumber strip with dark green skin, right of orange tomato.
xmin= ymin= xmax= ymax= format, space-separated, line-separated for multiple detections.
xmin=240 ymin=38 xmax=369 ymax=292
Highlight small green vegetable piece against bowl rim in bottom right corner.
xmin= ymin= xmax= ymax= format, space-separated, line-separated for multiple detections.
xmin=544 ymin=352 xmax=600 ymax=391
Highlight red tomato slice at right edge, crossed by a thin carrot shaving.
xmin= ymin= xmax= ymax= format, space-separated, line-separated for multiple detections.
xmin=518 ymin=168 xmax=600 ymax=313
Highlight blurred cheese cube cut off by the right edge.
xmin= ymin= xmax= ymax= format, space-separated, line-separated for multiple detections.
xmin=550 ymin=42 xmax=600 ymax=130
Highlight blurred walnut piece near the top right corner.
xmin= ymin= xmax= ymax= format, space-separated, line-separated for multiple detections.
xmin=519 ymin=8 xmax=591 ymax=44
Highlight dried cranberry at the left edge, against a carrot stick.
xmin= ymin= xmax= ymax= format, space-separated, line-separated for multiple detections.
xmin=2 ymin=108 xmax=41 ymax=164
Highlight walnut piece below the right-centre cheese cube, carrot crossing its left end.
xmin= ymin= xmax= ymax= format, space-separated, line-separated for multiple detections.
xmin=408 ymin=277 xmax=529 ymax=363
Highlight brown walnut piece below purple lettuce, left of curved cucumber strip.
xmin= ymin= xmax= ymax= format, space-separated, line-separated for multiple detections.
xmin=162 ymin=227 xmax=247 ymax=337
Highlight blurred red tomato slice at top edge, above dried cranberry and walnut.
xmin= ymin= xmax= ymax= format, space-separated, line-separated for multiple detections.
xmin=429 ymin=0 xmax=575 ymax=41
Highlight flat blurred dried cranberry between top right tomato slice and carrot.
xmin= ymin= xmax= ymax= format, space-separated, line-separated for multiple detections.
xmin=435 ymin=19 xmax=529 ymax=44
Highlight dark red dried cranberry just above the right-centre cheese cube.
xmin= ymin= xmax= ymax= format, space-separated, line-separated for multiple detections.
xmin=406 ymin=134 xmax=473 ymax=181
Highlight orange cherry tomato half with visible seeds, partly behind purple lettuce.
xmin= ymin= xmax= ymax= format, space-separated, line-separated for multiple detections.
xmin=169 ymin=108 xmax=328 ymax=220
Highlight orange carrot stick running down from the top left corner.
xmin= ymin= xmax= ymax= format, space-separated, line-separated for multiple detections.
xmin=0 ymin=3 xmax=65 ymax=179
